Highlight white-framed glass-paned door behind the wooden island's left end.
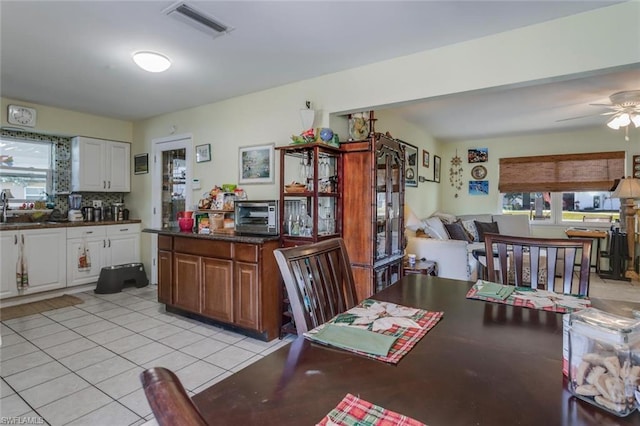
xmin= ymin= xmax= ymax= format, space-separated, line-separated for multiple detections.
xmin=151 ymin=135 xmax=193 ymax=284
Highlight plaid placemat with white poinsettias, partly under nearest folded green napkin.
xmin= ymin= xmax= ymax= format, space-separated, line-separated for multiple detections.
xmin=304 ymin=299 xmax=444 ymax=364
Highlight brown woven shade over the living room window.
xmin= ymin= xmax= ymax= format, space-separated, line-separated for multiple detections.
xmin=498 ymin=151 xmax=625 ymax=193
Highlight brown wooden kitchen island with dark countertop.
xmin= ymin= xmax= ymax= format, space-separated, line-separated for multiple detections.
xmin=148 ymin=229 xmax=282 ymax=341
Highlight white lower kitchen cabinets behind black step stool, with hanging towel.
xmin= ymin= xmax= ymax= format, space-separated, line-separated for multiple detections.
xmin=67 ymin=223 xmax=140 ymax=286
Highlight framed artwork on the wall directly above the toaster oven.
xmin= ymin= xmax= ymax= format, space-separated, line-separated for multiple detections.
xmin=238 ymin=144 xmax=275 ymax=183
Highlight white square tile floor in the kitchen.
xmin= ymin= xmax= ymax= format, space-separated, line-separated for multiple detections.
xmin=0 ymin=286 xmax=292 ymax=426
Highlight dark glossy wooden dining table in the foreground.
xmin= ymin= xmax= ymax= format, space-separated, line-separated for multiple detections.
xmin=192 ymin=274 xmax=640 ymax=426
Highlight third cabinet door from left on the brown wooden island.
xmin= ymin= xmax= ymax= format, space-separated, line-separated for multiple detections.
xmin=202 ymin=257 xmax=233 ymax=322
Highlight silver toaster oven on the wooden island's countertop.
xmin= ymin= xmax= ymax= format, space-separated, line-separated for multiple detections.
xmin=234 ymin=200 xmax=280 ymax=235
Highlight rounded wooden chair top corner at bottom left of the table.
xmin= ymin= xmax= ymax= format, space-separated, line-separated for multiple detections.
xmin=140 ymin=367 xmax=207 ymax=426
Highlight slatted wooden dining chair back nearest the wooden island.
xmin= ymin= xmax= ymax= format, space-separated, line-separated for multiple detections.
xmin=273 ymin=238 xmax=357 ymax=335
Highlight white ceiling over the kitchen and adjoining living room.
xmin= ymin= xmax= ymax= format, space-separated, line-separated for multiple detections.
xmin=0 ymin=0 xmax=640 ymax=140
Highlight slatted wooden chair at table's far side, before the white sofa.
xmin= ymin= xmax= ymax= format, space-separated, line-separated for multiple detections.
xmin=484 ymin=233 xmax=592 ymax=296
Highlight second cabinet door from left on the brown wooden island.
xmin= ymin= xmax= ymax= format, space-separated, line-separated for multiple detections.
xmin=173 ymin=253 xmax=201 ymax=312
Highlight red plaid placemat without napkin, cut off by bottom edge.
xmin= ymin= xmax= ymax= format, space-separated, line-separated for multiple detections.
xmin=318 ymin=393 xmax=426 ymax=426
